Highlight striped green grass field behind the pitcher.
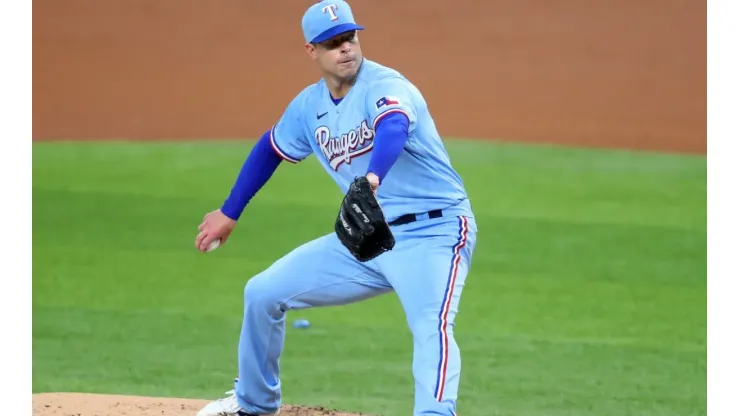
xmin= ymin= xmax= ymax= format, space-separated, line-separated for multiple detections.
xmin=33 ymin=140 xmax=707 ymax=416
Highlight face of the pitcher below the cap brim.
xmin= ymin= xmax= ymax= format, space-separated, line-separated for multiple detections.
xmin=308 ymin=31 xmax=362 ymax=79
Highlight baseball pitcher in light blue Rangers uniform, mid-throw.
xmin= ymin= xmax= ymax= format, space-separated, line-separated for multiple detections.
xmin=195 ymin=0 xmax=477 ymax=416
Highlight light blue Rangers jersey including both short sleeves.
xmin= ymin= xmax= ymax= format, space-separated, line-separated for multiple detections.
xmin=271 ymin=59 xmax=472 ymax=221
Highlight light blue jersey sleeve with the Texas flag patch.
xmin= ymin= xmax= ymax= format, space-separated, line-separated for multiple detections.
xmin=365 ymin=78 xmax=416 ymax=131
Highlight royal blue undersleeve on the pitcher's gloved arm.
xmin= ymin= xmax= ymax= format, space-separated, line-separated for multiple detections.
xmin=367 ymin=113 xmax=409 ymax=183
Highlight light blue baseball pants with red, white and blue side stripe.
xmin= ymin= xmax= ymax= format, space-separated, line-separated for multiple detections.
xmin=235 ymin=216 xmax=477 ymax=416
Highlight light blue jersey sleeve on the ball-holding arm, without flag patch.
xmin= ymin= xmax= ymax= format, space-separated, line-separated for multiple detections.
xmin=270 ymin=90 xmax=313 ymax=163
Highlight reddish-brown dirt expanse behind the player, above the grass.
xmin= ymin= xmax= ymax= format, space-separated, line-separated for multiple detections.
xmin=33 ymin=0 xmax=706 ymax=153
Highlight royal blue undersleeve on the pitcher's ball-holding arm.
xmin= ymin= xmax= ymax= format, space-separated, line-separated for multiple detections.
xmin=221 ymin=131 xmax=282 ymax=221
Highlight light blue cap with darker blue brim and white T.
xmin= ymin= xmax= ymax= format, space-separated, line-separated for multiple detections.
xmin=303 ymin=0 xmax=365 ymax=43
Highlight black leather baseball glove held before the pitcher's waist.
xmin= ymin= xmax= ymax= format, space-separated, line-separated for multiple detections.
xmin=334 ymin=176 xmax=396 ymax=262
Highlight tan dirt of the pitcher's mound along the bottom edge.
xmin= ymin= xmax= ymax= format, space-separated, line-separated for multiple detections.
xmin=33 ymin=393 xmax=370 ymax=416
